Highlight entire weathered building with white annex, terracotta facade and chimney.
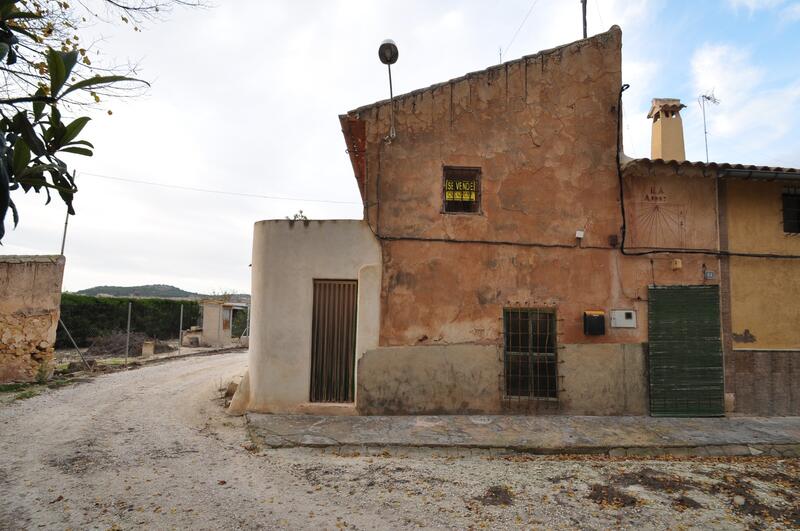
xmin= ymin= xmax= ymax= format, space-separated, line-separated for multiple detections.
xmin=237 ymin=26 xmax=800 ymax=416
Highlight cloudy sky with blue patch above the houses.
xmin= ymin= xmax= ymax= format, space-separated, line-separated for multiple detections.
xmin=0 ymin=0 xmax=800 ymax=293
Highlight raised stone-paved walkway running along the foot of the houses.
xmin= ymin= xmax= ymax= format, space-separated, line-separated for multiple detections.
xmin=247 ymin=413 xmax=800 ymax=456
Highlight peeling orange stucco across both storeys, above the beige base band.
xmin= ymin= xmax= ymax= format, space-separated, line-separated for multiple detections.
xmin=349 ymin=27 xmax=718 ymax=346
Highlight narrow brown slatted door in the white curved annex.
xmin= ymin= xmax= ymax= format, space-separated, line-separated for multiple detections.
xmin=310 ymin=280 xmax=358 ymax=402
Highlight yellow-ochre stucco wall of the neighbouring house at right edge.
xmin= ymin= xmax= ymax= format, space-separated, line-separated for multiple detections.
xmin=726 ymin=180 xmax=800 ymax=350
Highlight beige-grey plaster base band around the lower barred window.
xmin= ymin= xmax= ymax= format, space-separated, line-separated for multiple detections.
xmin=356 ymin=344 xmax=648 ymax=415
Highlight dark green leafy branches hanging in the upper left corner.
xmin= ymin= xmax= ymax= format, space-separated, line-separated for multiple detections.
xmin=0 ymin=0 xmax=200 ymax=242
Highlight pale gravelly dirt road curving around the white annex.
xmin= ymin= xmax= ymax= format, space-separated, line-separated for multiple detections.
xmin=0 ymin=353 xmax=800 ymax=529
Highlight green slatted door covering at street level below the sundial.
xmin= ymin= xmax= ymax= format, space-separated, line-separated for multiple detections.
xmin=648 ymin=286 xmax=725 ymax=417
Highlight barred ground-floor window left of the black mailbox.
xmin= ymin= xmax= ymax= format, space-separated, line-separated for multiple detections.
xmin=503 ymin=308 xmax=558 ymax=399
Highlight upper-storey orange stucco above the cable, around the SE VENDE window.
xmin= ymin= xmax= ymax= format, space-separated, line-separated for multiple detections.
xmin=358 ymin=28 xmax=621 ymax=251
